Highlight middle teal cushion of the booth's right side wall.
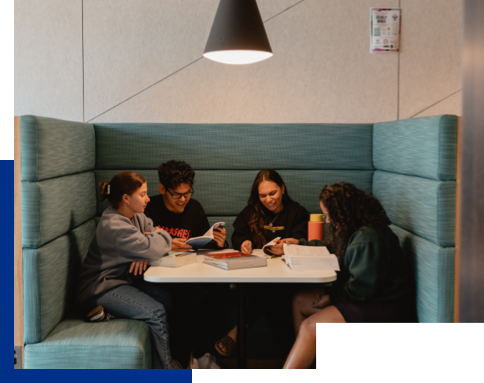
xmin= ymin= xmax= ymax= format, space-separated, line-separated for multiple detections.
xmin=373 ymin=171 xmax=456 ymax=247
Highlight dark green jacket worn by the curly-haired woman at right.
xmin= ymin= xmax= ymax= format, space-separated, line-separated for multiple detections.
xmin=300 ymin=226 xmax=414 ymax=304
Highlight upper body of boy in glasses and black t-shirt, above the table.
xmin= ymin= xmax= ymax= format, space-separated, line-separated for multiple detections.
xmin=145 ymin=160 xmax=228 ymax=251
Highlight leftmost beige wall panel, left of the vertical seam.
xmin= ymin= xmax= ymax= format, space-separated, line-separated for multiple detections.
xmin=13 ymin=0 xmax=83 ymax=121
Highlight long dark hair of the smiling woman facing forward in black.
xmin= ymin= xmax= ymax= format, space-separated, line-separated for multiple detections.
xmin=248 ymin=169 xmax=293 ymax=248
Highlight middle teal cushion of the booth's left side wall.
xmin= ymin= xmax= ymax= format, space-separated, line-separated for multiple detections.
xmin=21 ymin=172 xmax=96 ymax=248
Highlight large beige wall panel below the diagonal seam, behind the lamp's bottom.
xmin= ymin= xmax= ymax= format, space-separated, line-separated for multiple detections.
xmin=94 ymin=0 xmax=398 ymax=123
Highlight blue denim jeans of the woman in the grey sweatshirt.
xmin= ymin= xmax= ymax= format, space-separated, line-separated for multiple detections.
xmin=91 ymin=280 xmax=173 ymax=369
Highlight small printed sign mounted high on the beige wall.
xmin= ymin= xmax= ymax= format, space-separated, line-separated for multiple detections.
xmin=370 ymin=8 xmax=402 ymax=52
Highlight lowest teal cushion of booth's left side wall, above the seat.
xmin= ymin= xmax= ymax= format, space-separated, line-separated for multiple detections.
xmin=23 ymin=219 xmax=96 ymax=344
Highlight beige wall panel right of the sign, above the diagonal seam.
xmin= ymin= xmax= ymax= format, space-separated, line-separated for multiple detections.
xmin=399 ymin=0 xmax=463 ymax=119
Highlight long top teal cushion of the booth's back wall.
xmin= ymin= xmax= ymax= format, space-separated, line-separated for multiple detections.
xmin=94 ymin=123 xmax=373 ymax=170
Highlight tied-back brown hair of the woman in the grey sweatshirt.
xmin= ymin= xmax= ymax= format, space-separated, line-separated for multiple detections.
xmin=98 ymin=170 xmax=146 ymax=209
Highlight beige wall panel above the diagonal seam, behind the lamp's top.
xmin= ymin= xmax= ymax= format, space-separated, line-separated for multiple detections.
xmin=84 ymin=0 xmax=297 ymax=120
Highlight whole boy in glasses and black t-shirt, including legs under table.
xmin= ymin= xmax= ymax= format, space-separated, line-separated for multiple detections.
xmin=145 ymin=160 xmax=229 ymax=366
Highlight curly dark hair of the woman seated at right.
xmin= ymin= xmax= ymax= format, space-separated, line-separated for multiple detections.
xmin=319 ymin=182 xmax=391 ymax=257
